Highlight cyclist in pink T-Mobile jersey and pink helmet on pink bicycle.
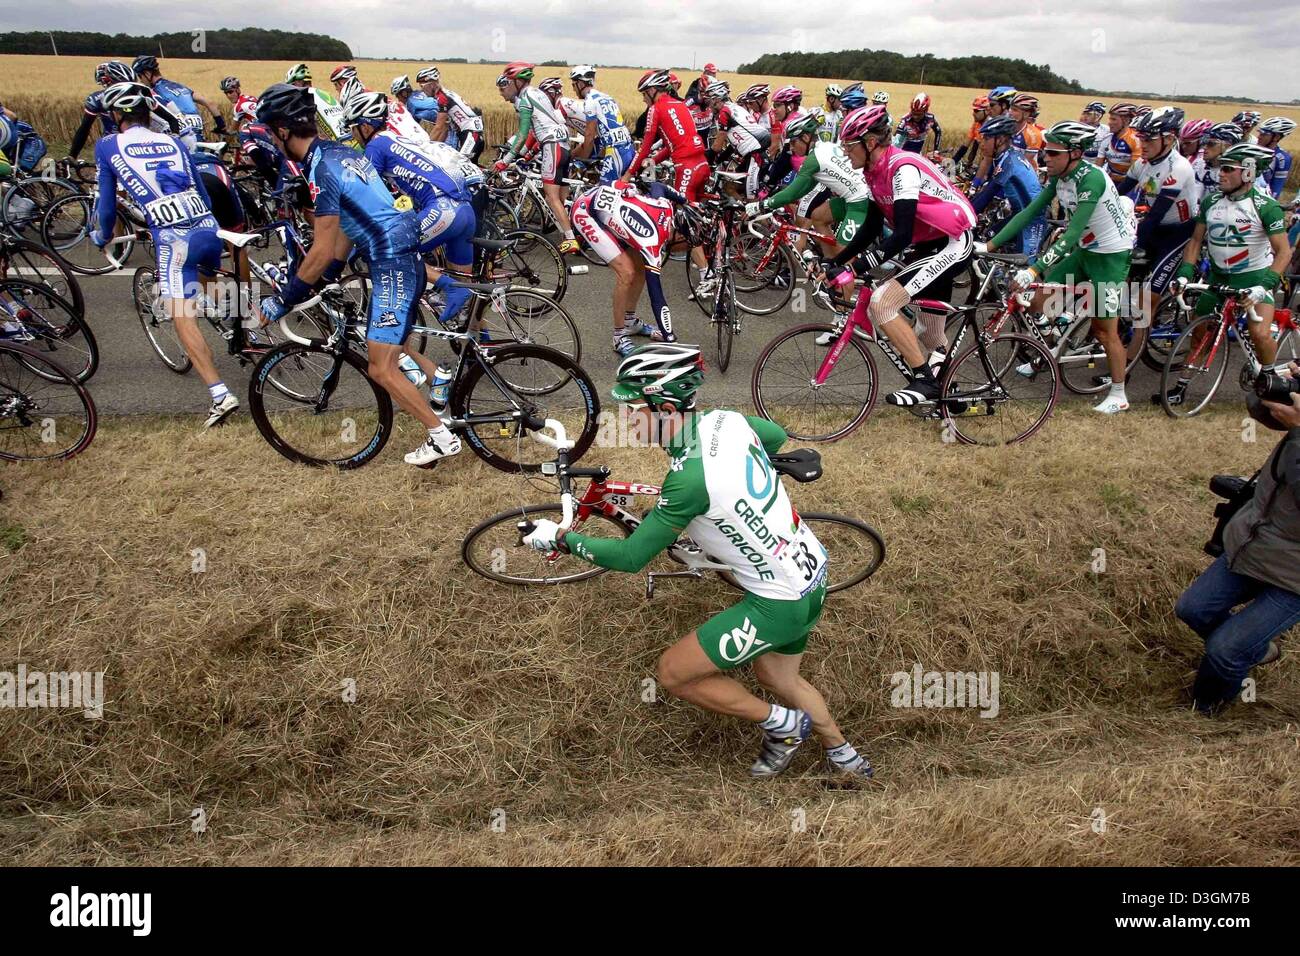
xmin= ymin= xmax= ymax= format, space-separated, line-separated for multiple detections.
xmin=819 ymin=105 xmax=975 ymax=406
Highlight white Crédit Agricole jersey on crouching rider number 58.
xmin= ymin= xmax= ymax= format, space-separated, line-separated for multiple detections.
xmin=655 ymin=410 xmax=827 ymax=601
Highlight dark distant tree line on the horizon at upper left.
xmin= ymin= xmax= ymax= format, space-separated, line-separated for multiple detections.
xmin=0 ymin=27 xmax=352 ymax=60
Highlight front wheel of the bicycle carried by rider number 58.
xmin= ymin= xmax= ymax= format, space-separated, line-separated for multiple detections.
xmin=460 ymin=505 xmax=628 ymax=585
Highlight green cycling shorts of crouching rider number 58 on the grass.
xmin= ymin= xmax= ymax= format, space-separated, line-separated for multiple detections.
xmin=696 ymin=580 xmax=826 ymax=671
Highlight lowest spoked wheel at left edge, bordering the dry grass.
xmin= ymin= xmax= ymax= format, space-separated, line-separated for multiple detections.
xmin=0 ymin=341 xmax=98 ymax=462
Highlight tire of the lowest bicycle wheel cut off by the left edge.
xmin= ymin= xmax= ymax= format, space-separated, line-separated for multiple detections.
xmin=0 ymin=341 xmax=99 ymax=462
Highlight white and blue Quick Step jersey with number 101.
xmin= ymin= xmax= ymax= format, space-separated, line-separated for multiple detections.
xmin=95 ymin=126 xmax=217 ymax=238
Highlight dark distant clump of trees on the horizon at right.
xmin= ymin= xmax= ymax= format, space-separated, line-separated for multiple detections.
xmin=736 ymin=49 xmax=1091 ymax=94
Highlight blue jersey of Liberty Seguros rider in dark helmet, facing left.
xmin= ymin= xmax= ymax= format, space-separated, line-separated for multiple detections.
xmin=306 ymin=139 xmax=420 ymax=263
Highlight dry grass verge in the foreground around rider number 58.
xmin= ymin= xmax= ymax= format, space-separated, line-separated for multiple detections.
xmin=0 ymin=405 xmax=1300 ymax=865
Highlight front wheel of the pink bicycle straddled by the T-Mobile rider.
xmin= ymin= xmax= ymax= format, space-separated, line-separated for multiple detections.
xmin=750 ymin=324 xmax=880 ymax=441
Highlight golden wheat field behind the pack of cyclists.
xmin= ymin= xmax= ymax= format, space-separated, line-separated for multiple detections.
xmin=0 ymin=55 xmax=1300 ymax=192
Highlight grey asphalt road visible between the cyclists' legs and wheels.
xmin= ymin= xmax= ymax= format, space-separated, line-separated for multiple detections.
xmin=48 ymin=252 xmax=1240 ymax=415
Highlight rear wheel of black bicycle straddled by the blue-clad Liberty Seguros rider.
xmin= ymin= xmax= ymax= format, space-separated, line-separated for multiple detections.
xmin=451 ymin=345 xmax=601 ymax=473
